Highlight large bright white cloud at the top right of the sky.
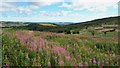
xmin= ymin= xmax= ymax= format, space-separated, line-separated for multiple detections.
xmin=59 ymin=0 xmax=119 ymax=11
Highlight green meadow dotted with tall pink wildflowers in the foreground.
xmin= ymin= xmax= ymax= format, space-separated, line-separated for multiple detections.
xmin=2 ymin=29 xmax=120 ymax=66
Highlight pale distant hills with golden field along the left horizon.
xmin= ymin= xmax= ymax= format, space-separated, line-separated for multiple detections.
xmin=0 ymin=21 xmax=71 ymax=27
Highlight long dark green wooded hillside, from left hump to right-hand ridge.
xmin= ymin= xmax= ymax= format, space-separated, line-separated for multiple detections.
xmin=18 ymin=17 xmax=118 ymax=34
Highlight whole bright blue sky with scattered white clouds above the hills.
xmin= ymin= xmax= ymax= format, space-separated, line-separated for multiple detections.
xmin=0 ymin=0 xmax=120 ymax=22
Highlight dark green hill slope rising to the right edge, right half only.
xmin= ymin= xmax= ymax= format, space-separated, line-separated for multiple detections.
xmin=64 ymin=16 xmax=120 ymax=32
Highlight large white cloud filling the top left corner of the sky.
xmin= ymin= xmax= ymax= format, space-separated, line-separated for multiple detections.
xmin=0 ymin=0 xmax=62 ymax=15
